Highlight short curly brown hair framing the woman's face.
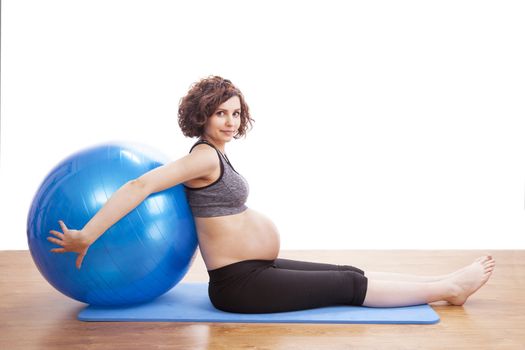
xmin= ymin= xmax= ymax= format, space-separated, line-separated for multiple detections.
xmin=178 ymin=75 xmax=255 ymax=139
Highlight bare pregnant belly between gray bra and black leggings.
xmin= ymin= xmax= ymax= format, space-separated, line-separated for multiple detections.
xmin=195 ymin=208 xmax=280 ymax=270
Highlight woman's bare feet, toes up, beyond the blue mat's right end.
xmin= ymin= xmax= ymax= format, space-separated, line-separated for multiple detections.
xmin=445 ymin=256 xmax=496 ymax=305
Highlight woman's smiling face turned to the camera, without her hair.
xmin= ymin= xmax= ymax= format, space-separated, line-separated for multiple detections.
xmin=203 ymin=96 xmax=241 ymax=143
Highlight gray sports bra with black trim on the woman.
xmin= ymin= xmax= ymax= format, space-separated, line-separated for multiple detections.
xmin=184 ymin=140 xmax=249 ymax=217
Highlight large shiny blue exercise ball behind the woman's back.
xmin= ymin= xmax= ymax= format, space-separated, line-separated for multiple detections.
xmin=27 ymin=143 xmax=197 ymax=306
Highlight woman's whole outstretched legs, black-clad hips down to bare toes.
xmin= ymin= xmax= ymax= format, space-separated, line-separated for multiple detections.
xmin=209 ymin=256 xmax=495 ymax=313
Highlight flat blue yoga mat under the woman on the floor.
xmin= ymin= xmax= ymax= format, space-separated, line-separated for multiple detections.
xmin=78 ymin=283 xmax=439 ymax=324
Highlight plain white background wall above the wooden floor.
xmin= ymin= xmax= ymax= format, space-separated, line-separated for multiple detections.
xmin=0 ymin=0 xmax=525 ymax=249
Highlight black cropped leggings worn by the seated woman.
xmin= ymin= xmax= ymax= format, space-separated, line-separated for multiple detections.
xmin=208 ymin=259 xmax=368 ymax=313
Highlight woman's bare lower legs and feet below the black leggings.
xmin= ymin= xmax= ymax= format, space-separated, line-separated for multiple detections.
xmin=363 ymin=257 xmax=495 ymax=307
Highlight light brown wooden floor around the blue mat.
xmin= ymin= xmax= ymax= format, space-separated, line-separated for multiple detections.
xmin=0 ymin=250 xmax=525 ymax=349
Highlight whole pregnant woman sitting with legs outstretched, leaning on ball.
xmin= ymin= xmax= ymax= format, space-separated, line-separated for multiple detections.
xmin=48 ymin=76 xmax=495 ymax=313
